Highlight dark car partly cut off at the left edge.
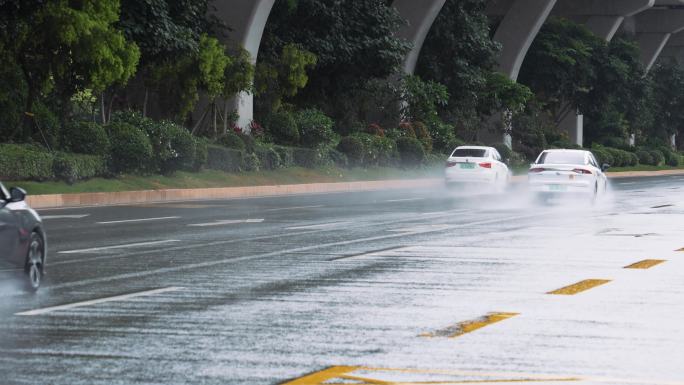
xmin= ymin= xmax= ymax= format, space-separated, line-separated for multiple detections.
xmin=0 ymin=183 xmax=47 ymax=290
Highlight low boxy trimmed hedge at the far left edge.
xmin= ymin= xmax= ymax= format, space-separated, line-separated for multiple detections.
xmin=0 ymin=144 xmax=54 ymax=181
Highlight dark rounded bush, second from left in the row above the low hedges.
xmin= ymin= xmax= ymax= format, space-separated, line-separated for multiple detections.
xmin=109 ymin=122 xmax=153 ymax=173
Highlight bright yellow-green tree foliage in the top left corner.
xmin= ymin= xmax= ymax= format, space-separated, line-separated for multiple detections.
xmin=0 ymin=0 xmax=140 ymax=135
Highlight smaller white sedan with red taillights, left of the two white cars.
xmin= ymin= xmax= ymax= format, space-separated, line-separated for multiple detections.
xmin=444 ymin=146 xmax=510 ymax=191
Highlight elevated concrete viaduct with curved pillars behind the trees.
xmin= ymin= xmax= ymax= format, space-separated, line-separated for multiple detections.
xmin=214 ymin=0 xmax=684 ymax=142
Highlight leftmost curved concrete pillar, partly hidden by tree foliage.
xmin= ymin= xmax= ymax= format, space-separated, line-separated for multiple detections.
xmin=212 ymin=0 xmax=275 ymax=128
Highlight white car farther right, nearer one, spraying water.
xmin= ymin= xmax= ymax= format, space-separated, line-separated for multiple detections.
xmin=527 ymin=150 xmax=610 ymax=199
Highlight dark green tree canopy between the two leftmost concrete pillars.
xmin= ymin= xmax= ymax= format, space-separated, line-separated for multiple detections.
xmin=259 ymin=0 xmax=410 ymax=117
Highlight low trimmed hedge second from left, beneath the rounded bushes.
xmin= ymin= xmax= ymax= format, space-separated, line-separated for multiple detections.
xmin=52 ymin=152 xmax=107 ymax=184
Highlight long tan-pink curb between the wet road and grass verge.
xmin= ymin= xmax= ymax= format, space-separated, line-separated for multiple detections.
xmin=27 ymin=170 xmax=684 ymax=209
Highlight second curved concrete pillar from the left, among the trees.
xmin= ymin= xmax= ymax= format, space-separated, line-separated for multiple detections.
xmin=392 ymin=0 xmax=446 ymax=74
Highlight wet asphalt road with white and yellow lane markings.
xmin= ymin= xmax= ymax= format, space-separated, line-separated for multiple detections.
xmin=0 ymin=177 xmax=684 ymax=385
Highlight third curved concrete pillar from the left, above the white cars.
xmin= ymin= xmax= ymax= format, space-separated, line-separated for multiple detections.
xmin=494 ymin=0 xmax=556 ymax=80
